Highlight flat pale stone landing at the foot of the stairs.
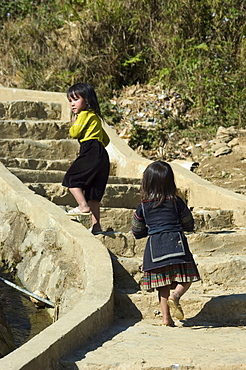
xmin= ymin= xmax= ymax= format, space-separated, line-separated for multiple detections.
xmin=62 ymin=319 xmax=246 ymax=370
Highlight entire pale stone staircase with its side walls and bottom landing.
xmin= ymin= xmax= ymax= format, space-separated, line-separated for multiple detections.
xmin=0 ymin=88 xmax=246 ymax=370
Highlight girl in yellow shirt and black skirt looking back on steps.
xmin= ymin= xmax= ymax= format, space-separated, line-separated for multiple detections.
xmin=62 ymin=83 xmax=110 ymax=233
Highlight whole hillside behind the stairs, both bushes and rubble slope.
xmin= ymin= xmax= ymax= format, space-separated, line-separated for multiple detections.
xmin=0 ymin=0 xmax=246 ymax=193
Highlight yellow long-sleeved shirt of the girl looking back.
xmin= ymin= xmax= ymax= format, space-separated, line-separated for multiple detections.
xmin=69 ymin=110 xmax=110 ymax=147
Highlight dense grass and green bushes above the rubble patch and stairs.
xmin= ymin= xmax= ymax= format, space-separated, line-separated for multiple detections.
xmin=0 ymin=0 xmax=246 ymax=130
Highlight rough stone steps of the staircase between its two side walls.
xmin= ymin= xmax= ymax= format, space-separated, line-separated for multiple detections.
xmin=0 ymin=99 xmax=246 ymax=368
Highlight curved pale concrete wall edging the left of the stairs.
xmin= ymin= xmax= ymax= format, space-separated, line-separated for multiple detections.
xmin=0 ymin=164 xmax=114 ymax=370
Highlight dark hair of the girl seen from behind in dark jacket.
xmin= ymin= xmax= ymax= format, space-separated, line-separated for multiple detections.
xmin=141 ymin=161 xmax=177 ymax=207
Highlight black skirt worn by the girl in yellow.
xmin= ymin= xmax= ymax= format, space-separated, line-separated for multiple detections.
xmin=62 ymin=140 xmax=110 ymax=202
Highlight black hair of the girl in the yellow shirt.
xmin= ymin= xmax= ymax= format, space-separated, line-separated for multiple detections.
xmin=67 ymin=83 xmax=101 ymax=117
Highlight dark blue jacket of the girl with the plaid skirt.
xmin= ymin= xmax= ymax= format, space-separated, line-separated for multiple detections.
xmin=132 ymin=197 xmax=194 ymax=271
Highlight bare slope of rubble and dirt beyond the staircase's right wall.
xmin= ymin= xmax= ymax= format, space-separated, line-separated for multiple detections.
xmin=111 ymin=85 xmax=246 ymax=195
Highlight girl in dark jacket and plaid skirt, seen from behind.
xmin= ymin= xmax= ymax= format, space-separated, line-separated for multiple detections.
xmin=132 ymin=161 xmax=200 ymax=326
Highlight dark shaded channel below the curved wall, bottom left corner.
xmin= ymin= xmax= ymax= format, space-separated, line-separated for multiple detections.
xmin=0 ymin=264 xmax=52 ymax=357
